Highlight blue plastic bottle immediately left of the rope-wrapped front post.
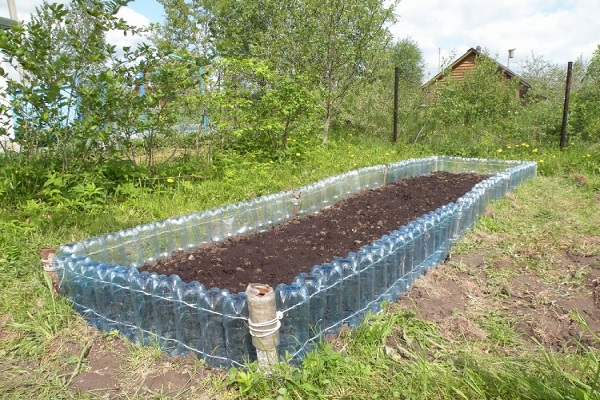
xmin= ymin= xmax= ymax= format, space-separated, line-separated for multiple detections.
xmin=223 ymin=292 xmax=256 ymax=364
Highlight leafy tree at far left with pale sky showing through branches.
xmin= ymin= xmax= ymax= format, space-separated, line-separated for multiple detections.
xmin=0 ymin=0 xmax=130 ymax=170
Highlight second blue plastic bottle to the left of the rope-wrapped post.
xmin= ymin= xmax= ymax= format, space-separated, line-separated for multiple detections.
xmin=200 ymin=288 xmax=230 ymax=367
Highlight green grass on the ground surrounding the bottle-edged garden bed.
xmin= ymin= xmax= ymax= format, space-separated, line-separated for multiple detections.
xmin=0 ymin=136 xmax=600 ymax=399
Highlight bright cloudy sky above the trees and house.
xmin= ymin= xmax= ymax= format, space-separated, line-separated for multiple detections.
xmin=0 ymin=0 xmax=600 ymax=79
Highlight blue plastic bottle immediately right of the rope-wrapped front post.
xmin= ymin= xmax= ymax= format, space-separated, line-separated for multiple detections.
xmin=275 ymin=283 xmax=310 ymax=359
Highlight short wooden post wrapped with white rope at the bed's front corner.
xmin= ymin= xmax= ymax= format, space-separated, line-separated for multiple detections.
xmin=246 ymin=283 xmax=281 ymax=373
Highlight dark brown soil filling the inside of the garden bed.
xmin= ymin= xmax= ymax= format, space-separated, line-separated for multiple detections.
xmin=140 ymin=172 xmax=486 ymax=293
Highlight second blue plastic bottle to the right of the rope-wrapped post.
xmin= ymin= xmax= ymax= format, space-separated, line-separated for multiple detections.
xmin=312 ymin=263 xmax=344 ymax=334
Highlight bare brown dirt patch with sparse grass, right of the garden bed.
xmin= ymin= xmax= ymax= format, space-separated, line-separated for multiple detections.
xmin=398 ymin=241 xmax=600 ymax=351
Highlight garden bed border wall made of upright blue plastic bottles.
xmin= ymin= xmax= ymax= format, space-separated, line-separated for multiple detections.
xmin=53 ymin=157 xmax=535 ymax=366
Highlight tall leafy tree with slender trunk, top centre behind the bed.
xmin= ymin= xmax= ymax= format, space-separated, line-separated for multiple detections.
xmin=171 ymin=0 xmax=396 ymax=142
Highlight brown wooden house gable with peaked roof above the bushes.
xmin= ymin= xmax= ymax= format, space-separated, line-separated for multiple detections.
xmin=421 ymin=47 xmax=531 ymax=99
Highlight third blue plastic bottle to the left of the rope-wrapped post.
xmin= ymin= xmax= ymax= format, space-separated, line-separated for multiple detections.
xmin=175 ymin=281 xmax=206 ymax=357
